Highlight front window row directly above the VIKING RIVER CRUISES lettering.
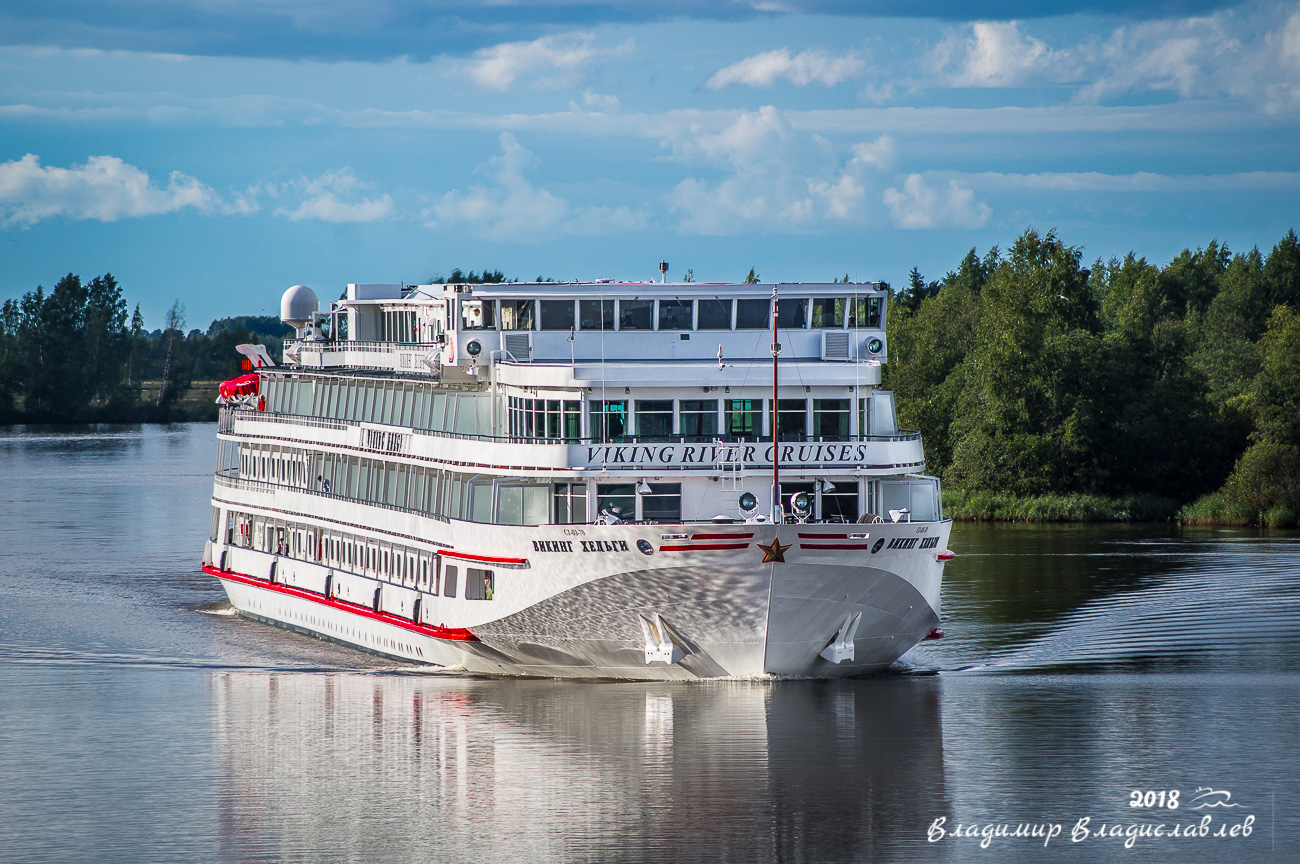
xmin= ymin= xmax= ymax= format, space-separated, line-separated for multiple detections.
xmin=590 ymin=399 xmax=867 ymax=442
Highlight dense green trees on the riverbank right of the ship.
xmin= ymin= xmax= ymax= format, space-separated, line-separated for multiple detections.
xmin=885 ymin=230 xmax=1300 ymax=526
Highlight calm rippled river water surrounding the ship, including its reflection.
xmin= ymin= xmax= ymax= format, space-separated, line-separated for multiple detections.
xmin=0 ymin=425 xmax=1300 ymax=864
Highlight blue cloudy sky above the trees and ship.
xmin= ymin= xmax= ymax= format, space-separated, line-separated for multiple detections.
xmin=0 ymin=0 xmax=1300 ymax=327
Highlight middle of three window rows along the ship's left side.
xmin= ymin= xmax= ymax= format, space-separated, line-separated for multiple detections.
xmin=239 ymin=443 xmax=588 ymax=525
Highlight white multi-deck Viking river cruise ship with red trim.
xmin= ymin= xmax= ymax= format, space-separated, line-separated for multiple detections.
xmin=203 ymin=272 xmax=953 ymax=680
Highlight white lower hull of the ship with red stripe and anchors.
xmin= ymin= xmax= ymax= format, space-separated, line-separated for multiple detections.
xmin=205 ymin=522 xmax=950 ymax=680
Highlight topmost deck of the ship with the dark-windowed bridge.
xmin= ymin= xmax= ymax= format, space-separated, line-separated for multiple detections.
xmin=286 ymin=281 xmax=888 ymax=378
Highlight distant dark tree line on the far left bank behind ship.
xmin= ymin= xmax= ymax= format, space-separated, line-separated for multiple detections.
xmin=0 ymin=273 xmax=289 ymax=424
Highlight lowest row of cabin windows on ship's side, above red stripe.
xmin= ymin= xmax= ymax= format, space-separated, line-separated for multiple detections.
xmin=222 ymin=508 xmax=495 ymax=600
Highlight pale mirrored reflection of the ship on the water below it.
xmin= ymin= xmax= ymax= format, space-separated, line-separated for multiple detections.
xmin=213 ymin=672 xmax=945 ymax=861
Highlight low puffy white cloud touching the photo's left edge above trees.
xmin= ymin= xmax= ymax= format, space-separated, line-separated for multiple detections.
xmin=0 ymin=153 xmax=233 ymax=226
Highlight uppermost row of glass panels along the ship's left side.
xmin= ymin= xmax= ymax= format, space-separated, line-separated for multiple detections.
xmin=263 ymin=375 xmax=493 ymax=435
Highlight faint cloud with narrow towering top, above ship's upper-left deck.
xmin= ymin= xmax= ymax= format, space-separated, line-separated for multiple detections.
xmin=428 ymin=133 xmax=646 ymax=240
